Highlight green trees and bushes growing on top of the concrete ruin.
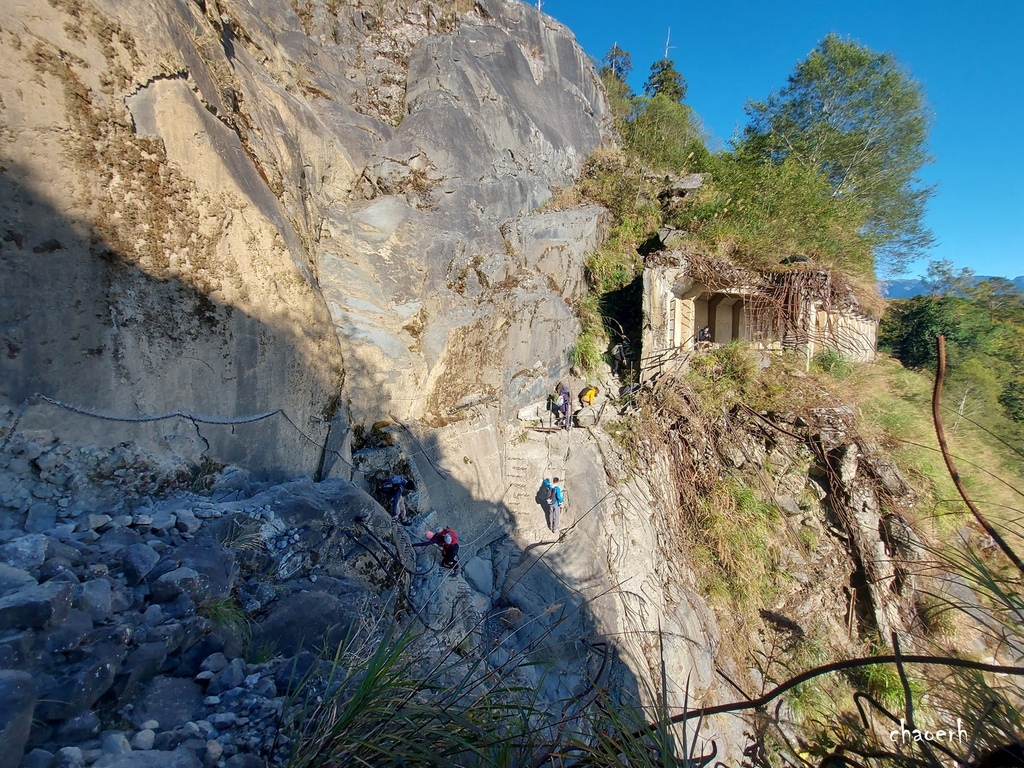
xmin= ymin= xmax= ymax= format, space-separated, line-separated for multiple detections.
xmin=574 ymin=35 xmax=931 ymax=376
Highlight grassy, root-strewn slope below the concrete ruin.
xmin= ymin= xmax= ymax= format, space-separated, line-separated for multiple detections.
xmin=609 ymin=344 xmax=1024 ymax=768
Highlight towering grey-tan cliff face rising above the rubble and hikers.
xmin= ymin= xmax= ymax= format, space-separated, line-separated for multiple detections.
xmin=0 ymin=0 xmax=607 ymax=475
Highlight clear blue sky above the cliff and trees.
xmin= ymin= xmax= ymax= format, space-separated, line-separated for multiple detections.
xmin=531 ymin=0 xmax=1024 ymax=278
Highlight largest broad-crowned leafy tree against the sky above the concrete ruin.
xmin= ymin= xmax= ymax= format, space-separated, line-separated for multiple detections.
xmin=737 ymin=35 xmax=932 ymax=272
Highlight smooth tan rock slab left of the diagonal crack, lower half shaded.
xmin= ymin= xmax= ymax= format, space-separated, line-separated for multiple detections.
xmin=0 ymin=3 xmax=343 ymax=474
